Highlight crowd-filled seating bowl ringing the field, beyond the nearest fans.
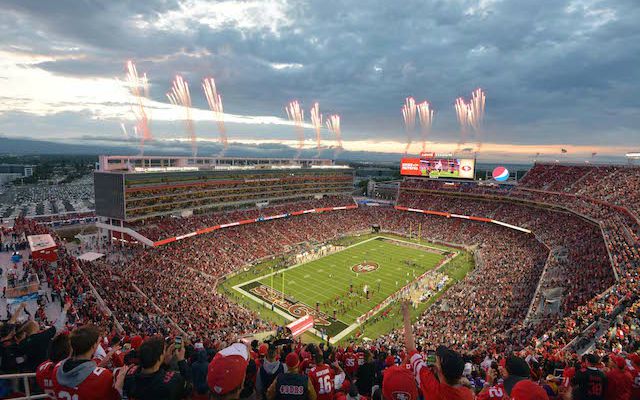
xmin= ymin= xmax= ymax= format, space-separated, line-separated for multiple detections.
xmin=2 ymin=164 xmax=640 ymax=398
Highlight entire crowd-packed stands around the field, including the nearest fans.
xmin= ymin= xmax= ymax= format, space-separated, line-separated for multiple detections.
xmin=0 ymin=164 xmax=640 ymax=400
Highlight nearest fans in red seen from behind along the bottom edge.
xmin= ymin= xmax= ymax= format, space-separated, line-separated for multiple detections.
xmin=5 ymin=296 xmax=640 ymax=400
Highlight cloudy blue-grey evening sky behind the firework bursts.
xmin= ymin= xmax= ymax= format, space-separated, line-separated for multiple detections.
xmin=0 ymin=0 xmax=640 ymax=159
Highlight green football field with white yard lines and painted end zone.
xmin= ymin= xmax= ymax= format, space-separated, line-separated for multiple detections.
xmin=234 ymin=237 xmax=453 ymax=336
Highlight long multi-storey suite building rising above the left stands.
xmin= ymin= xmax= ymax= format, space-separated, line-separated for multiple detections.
xmin=94 ymin=156 xmax=354 ymax=226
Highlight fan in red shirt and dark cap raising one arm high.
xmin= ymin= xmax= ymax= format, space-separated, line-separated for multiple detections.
xmin=402 ymin=302 xmax=474 ymax=400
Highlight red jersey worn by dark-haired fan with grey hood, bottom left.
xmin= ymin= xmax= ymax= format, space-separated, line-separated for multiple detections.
xmin=52 ymin=363 xmax=120 ymax=400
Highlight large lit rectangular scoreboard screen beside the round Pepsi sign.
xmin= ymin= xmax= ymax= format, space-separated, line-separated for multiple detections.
xmin=400 ymin=157 xmax=476 ymax=179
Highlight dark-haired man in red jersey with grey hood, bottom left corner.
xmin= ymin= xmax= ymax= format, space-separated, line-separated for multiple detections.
xmin=53 ymin=325 xmax=126 ymax=400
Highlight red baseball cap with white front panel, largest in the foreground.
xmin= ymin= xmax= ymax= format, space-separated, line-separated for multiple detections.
xmin=207 ymin=343 xmax=249 ymax=395
